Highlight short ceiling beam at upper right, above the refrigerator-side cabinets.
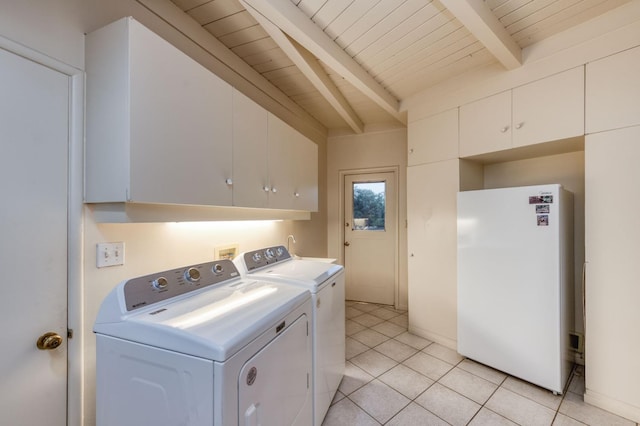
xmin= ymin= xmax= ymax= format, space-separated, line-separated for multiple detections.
xmin=440 ymin=0 xmax=522 ymax=70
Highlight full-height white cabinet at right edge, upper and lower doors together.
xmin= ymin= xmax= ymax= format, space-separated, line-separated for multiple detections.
xmin=584 ymin=42 xmax=640 ymax=422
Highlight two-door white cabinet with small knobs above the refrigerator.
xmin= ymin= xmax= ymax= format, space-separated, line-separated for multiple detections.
xmin=460 ymin=67 xmax=584 ymax=157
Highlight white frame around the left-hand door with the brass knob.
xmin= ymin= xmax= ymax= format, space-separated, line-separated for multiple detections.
xmin=0 ymin=35 xmax=85 ymax=426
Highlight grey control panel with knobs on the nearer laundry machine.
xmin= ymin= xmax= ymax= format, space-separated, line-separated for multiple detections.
xmin=123 ymin=259 xmax=240 ymax=311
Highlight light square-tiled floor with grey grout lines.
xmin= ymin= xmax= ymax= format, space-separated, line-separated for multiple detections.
xmin=323 ymin=301 xmax=637 ymax=426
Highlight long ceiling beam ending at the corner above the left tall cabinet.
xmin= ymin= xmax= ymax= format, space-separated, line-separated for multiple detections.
xmin=238 ymin=0 xmax=406 ymax=124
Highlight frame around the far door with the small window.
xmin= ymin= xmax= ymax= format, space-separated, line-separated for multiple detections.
xmin=339 ymin=166 xmax=400 ymax=309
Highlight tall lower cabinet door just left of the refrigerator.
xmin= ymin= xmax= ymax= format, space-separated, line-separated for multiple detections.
xmin=407 ymin=159 xmax=460 ymax=344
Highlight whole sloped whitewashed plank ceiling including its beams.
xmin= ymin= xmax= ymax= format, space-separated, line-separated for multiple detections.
xmin=171 ymin=0 xmax=629 ymax=133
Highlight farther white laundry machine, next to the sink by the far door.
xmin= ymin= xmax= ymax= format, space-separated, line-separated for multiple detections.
xmin=234 ymin=246 xmax=345 ymax=426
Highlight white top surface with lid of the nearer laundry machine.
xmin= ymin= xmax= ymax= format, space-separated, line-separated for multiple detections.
xmin=94 ymin=280 xmax=310 ymax=362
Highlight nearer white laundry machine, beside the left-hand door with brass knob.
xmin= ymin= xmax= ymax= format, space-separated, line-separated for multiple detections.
xmin=94 ymin=260 xmax=313 ymax=426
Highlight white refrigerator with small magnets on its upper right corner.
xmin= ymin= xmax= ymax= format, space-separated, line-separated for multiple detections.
xmin=458 ymin=184 xmax=573 ymax=394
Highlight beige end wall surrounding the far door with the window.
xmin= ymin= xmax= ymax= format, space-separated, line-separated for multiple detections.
xmin=326 ymin=128 xmax=408 ymax=309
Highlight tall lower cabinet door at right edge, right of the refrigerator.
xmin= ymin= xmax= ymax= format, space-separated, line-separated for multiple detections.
xmin=585 ymin=126 xmax=640 ymax=407
